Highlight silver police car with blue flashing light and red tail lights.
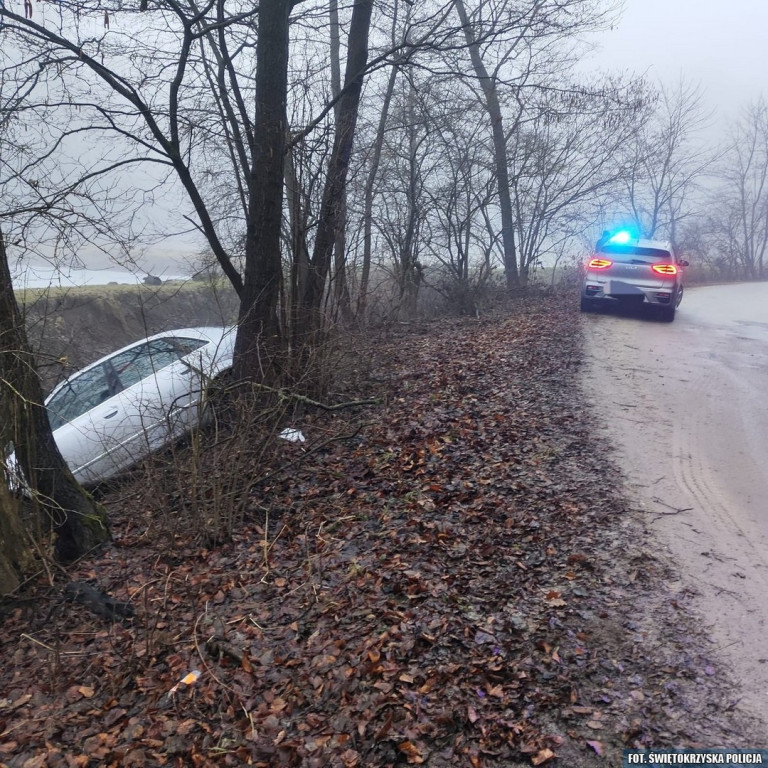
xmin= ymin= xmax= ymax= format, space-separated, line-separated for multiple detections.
xmin=581 ymin=230 xmax=688 ymax=323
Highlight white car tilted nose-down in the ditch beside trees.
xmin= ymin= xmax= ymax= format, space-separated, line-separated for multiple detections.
xmin=21 ymin=327 xmax=236 ymax=485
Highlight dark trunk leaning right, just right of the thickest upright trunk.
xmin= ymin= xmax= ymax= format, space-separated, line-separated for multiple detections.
xmin=299 ymin=0 xmax=373 ymax=343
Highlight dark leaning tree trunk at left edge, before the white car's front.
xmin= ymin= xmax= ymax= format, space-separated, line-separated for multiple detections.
xmin=0 ymin=225 xmax=109 ymax=562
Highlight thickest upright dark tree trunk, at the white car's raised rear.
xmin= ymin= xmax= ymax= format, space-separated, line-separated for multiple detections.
xmin=234 ymin=0 xmax=292 ymax=382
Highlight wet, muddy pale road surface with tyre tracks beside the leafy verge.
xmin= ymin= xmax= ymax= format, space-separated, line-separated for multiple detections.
xmin=582 ymin=283 xmax=768 ymax=733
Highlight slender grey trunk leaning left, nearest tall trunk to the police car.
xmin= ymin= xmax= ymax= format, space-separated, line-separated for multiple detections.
xmin=454 ymin=0 xmax=520 ymax=290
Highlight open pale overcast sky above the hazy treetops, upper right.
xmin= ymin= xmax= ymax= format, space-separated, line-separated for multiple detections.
xmin=593 ymin=0 xmax=768 ymax=135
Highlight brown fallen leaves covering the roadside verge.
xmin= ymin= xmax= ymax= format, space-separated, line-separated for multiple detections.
xmin=0 ymin=296 xmax=765 ymax=768
